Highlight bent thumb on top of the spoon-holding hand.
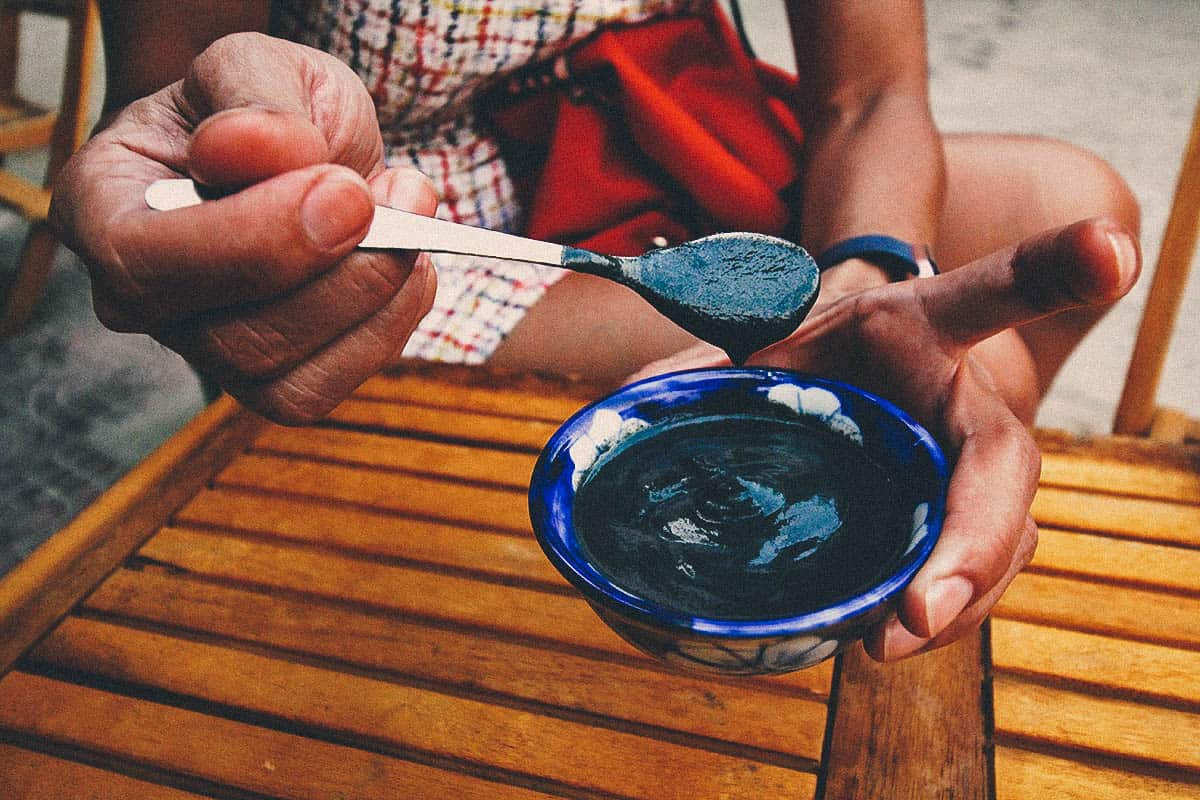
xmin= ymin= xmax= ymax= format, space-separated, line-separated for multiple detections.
xmin=181 ymin=34 xmax=383 ymax=187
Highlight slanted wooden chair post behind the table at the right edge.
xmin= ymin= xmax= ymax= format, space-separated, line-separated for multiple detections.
xmin=1112 ymin=98 xmax=1200 ymax=444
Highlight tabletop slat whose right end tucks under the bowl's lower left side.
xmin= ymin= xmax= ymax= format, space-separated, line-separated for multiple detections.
xmin=124 ymin=529 xmax=835 ymax=695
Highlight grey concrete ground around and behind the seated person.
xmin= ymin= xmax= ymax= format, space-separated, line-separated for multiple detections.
xmin=0 ymin=0 xmax=1200 ymax=572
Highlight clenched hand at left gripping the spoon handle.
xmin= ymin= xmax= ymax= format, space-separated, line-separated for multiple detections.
xmin=50 ymin=34 xmax=437 ymax=423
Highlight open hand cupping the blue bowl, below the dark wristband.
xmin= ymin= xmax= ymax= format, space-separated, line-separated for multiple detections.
xmin=640 ymin=219 xmax=1139 ymax=661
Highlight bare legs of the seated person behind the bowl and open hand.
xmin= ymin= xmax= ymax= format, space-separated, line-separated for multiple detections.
xmin=490 ymin=134 xmax=1139 ymax=390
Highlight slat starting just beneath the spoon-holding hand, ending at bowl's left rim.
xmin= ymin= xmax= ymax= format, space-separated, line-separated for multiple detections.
xmin=254 ymin=426 xmax=536 ymax=491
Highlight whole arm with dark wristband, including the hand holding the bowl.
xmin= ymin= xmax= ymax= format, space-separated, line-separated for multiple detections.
xmin=642 ymin=0 xmax=1139 ymax=660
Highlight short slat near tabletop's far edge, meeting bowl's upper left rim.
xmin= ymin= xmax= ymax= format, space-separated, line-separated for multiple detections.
xmin=329 ymin=396 xmax=558 ymax=453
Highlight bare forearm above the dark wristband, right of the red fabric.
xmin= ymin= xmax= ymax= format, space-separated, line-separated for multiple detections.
xmin=788 ymin=0 xmax=946 ymax=290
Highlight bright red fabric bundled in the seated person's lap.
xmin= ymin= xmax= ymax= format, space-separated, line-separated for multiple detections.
xmin=496 ymin=11 xmax=802 ymax=255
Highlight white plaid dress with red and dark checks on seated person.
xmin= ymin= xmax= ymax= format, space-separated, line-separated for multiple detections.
xmin=275 ymin=0 xmax=712 ymax=363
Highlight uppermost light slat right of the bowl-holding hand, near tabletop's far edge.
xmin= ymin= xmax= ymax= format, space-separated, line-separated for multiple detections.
xmin=1039 ymin=452 xmax=1200 ymax=505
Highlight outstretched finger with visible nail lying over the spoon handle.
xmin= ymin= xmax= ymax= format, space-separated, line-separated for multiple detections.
xmin=103 ymin=164 xmax=374 ymax=324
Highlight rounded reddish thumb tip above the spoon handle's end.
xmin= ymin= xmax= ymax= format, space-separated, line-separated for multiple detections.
xmin=187 ymin=107 xmax=329 ymax=187
